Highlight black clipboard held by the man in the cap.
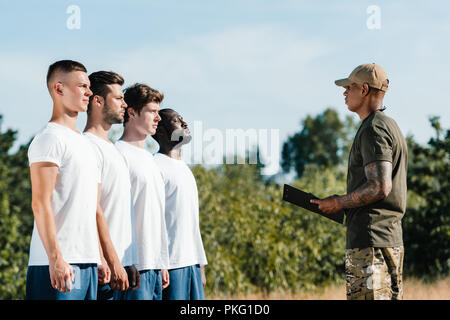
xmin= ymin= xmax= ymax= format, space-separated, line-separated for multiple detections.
xmin=283 ymin=184 xmax=344 ymax=224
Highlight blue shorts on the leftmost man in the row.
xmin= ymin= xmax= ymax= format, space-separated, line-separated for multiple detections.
xmin=25 ymin=263 xmax=98 ymax=300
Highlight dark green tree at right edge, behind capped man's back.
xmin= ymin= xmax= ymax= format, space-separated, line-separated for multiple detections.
xmin=403 ymin=117 xmax=450 ymax=279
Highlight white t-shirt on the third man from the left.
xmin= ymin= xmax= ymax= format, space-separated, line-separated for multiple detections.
xmin=116 ymin=140 xmax=169 ymax=271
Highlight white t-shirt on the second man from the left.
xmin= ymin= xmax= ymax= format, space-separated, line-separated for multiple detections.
xmin=84 ymin=132 xmax=137 ymax=266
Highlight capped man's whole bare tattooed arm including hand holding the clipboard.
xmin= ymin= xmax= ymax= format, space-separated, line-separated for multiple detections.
xmin=311 ymin=161 xmax=392 ymax=214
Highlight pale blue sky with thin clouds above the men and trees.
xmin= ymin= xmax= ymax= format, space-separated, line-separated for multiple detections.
xmin=0 ymin=0 xmax=450 ymax=175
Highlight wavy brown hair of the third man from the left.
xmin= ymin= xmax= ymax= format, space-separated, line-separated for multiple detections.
xmin=123 ymin=83 xmax=164 ymax=125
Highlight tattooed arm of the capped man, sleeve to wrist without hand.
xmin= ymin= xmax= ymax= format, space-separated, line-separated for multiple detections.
xmin=339 ymin=161 xmax=392 ymax=208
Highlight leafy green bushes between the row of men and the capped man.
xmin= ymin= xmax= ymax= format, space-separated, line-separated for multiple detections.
xmin=193 ymin=165 xmax=345 ymax=296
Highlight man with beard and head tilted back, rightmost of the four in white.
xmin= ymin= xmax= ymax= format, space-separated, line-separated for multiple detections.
xmin=153 ymin=109 xmax=207 ymax=300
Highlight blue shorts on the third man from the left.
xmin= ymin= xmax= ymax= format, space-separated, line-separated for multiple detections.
xmin=114 ymin=269 xmax=162 ymax=300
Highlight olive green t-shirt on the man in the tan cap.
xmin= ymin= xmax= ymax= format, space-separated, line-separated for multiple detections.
xmin=345 ymin=111 xmax=408 ymax=249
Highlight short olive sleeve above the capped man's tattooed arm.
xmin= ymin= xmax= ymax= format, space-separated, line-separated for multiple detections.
xmin=360 ymin=126 xmax=393 ymax=166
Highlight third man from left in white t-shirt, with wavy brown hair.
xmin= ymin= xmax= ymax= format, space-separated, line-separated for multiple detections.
xmin=116 ymin=84 xmax=169 ymax=300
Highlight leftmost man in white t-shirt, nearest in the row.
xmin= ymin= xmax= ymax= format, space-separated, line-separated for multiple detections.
xmin=26 ymin=60 xmax=100 ymax=300
